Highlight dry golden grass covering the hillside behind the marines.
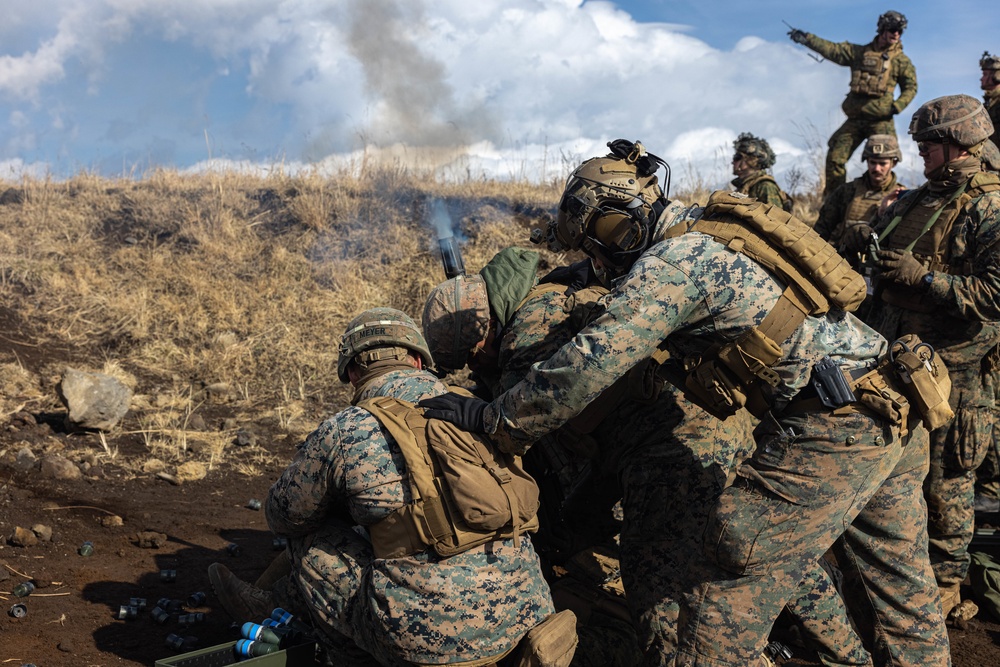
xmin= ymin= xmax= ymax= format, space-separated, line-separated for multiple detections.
xmin=0 ymin=165 xmax=820 ymax=475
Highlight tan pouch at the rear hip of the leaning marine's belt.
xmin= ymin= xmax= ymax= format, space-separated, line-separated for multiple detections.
xmin=889 ymin=334 xmax=955 ymax=431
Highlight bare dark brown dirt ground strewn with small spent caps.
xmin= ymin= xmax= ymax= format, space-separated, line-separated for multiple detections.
xmin=0 ymin=402 xmax=1000 ymax=667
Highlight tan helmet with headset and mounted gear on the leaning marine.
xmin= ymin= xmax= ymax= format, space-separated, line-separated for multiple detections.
xmin=547 ymin=139 xmax=669 ymax=270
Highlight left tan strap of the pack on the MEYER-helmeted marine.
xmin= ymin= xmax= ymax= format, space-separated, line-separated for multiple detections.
xmin=358 ymin=396 xmax=452 ymax=558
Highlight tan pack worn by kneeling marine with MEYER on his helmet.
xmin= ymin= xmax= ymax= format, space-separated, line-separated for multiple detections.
xmin=358 ymin=396 xmax=538 ymax=558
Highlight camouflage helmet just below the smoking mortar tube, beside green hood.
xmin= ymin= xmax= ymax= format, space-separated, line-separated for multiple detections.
xmin=422 ymin=274 xmax=490 ymax=371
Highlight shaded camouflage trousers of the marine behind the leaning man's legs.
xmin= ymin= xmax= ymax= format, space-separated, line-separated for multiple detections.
xmin=621 ymin=401 xmax=869 ymax=666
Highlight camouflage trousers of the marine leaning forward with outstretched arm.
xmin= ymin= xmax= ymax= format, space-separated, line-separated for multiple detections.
xmin=676 ymin=414 xmax=950 ymax=667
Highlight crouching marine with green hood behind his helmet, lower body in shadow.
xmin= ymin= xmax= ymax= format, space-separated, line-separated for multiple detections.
xmin=421 ymin=248 xmax=640 ymax=667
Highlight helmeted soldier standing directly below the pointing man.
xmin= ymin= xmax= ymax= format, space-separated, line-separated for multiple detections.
xmin=813 ymin=134 xmax=906 ymax=252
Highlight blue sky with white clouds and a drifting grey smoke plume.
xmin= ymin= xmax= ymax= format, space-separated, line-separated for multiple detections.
xmin=0 ymin=0 xmax=1000 ymax=187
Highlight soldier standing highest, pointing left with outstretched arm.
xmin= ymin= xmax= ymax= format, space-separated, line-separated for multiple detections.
xmin=788 ymin=11 xmax=917 ymax=197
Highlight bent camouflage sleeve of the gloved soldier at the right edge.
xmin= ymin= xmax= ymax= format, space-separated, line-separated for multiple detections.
xmin=920 ymin=192 xmax=1000 ymax=321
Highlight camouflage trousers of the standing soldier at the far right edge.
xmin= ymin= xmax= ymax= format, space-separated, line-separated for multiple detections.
xmin=924 ymin=367 xmax=995 ymax=588
